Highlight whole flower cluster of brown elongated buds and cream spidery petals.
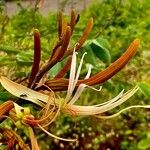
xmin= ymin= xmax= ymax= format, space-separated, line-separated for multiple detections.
xmin=0 ymin=11 xmax=150 ymax=150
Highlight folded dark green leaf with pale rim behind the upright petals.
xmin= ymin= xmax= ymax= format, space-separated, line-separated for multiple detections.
xmin=90 ymin=38 xmax=111 ymax=64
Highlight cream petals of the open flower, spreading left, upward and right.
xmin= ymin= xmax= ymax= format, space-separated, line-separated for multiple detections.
xmin=0 ymin=43 xmax=142 ymax=116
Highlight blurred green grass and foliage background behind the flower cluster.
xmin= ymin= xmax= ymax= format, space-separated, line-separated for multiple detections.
xmin=0 ymin=0 xmax=150 ymax=150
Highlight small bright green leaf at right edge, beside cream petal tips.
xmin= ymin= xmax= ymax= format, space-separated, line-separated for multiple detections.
xmin=138 ymin=83 xmax=150 ymax=98
